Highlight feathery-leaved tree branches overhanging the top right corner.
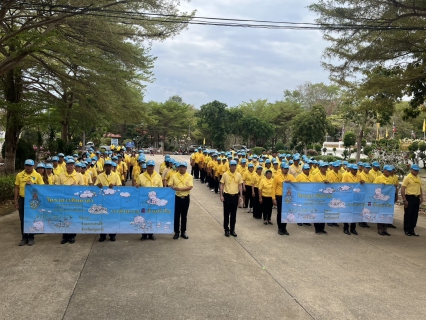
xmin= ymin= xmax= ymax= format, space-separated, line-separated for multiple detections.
xmin=310 ymin=0 xmax=426 ymax=116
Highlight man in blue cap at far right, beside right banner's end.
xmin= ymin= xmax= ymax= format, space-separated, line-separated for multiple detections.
xmin=401 ymin=164 xmax=423 ymax=237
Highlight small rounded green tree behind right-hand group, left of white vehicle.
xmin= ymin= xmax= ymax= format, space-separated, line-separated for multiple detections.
xmin=293 ymin=106 xmax=327 ymax=154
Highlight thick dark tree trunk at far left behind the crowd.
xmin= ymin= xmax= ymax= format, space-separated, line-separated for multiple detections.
xmin=4 ymin=69 xmax=23 ymax=174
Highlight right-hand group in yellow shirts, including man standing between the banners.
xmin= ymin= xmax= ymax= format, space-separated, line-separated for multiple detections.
xmin=191 ymin=148 xmax=423 ymax=236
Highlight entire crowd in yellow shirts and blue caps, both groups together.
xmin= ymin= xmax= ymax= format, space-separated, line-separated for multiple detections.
xmin=11 ymin=148 xmax=423 ymax=246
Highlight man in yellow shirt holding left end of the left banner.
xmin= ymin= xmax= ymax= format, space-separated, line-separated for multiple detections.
xmin=14 ymin=159 xmax=44 ymax=247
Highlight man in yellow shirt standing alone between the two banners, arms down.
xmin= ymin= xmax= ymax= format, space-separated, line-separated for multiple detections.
xmin=220 ymin=160 xmax=243 ymax=237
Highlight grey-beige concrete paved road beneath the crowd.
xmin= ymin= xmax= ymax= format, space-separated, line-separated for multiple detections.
xmin=0 ymin=156 xmax=426 ymax=319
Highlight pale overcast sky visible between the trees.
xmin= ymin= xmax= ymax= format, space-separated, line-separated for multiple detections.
xmin=146 ymin=0 xmax=329 ymax=108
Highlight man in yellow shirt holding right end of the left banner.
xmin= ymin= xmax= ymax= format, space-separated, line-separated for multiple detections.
xmin=170 ymin=162 xmax=194 ymax=240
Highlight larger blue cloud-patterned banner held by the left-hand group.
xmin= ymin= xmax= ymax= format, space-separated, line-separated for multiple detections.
xmin=24 ymin=185 xmax=175 ymax=234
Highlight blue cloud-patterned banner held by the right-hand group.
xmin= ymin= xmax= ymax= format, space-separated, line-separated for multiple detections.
xmin=281 ymin=183 xmax=395 ymax=223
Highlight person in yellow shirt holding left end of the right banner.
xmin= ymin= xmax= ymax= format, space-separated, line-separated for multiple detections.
xmin=272 ymin=162 xmax=296 ymax=236
